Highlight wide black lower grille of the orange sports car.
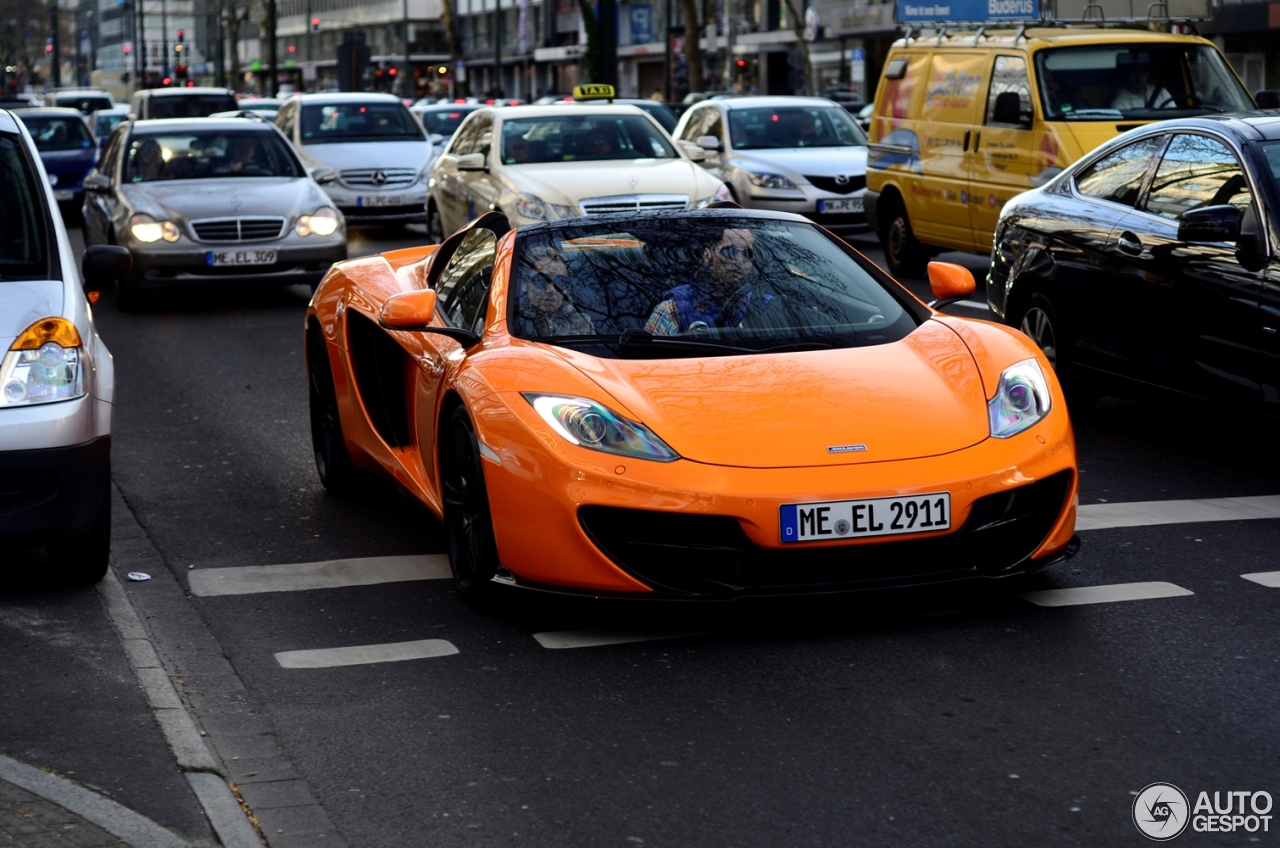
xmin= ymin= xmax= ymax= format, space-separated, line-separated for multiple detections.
xmin=577 ymin=471 xmax=1071 ymax=598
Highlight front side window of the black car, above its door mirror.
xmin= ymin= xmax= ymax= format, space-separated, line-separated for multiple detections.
xmin=1147 ymin=133 xmax=1252 ymax=220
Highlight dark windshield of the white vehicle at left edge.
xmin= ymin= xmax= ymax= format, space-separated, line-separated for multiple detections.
xmin=0 ymin=132 xmax=49 ymax=282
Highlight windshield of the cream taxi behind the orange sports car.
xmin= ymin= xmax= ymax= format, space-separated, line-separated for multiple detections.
xmin=502 ymin=114 xmax=678 ymax=165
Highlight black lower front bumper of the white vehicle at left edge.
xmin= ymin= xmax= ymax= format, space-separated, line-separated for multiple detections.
xmin=0 ymin=436 xmax=111 ymax=547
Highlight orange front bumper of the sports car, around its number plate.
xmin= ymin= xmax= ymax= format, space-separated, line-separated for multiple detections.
xmin=476 ymin=404 xmax=1078 ymax=599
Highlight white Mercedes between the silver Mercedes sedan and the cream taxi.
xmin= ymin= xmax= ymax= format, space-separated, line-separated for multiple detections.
xmin=275 ymin=92 xmax=434 ymax=224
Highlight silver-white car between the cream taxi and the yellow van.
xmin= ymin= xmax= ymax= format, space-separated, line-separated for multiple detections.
xmin=675 ymin=97 xmax=868 ymax=236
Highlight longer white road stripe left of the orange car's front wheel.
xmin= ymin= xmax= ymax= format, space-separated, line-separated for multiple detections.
xmin=187 ymin=553 xmax=449 ymax=597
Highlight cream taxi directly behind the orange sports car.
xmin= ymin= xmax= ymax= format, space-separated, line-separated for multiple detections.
xmin=426 ymin=104 xmax=728 ymax=236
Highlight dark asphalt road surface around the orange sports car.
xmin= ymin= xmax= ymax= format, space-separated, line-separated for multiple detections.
xmin=12 ymin=229 xmax=1280 ymax=848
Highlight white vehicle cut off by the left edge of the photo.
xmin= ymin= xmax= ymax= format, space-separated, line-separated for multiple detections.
xmin=0 ymin=111 xmax=131 ymax=583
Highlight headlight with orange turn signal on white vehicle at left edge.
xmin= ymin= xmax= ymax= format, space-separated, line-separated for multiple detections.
xmin=0 ymin=318 xmax=84 ymax=407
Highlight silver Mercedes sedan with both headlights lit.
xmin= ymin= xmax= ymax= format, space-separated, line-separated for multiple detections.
xmin=84 ymin=118 xmax=347 ymax=310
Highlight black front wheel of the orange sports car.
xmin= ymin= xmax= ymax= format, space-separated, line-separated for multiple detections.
xmin=440 ymin=406 xmax=498 ymax=603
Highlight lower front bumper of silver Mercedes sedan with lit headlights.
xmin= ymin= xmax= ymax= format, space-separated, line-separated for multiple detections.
xmin=129 ymin=240 xmax=347 ymax=289
